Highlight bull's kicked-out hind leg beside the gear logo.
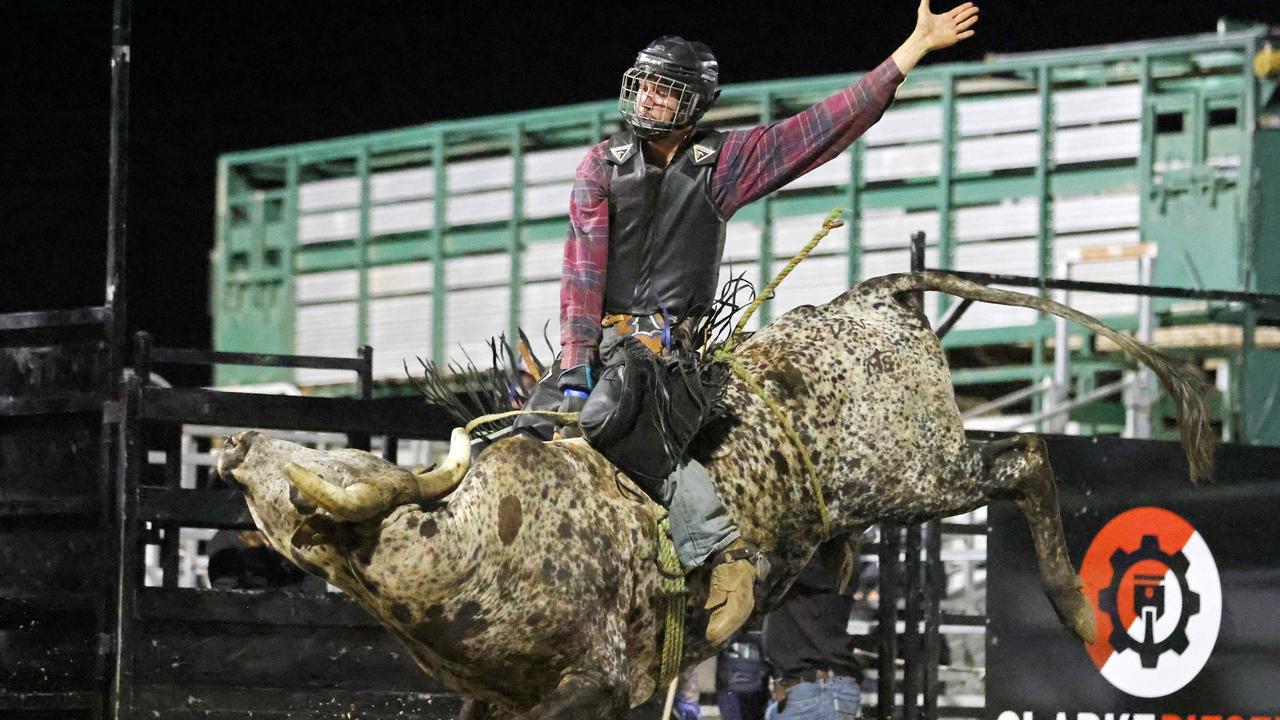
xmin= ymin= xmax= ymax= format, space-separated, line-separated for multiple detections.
xmin=982 ymin=436 xmax=1097 ymax=643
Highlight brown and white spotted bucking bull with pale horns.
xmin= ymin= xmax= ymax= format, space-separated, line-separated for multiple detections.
xmin=219 ymin=272 xmax=1212 ymax=717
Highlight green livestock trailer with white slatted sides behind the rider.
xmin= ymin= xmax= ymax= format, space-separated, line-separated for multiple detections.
xmin=211 ymin=23 xmax=1280 ymax=443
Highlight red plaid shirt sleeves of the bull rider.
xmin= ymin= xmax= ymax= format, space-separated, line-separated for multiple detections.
xmin=561 ymin=58 xmax=902 ymax=369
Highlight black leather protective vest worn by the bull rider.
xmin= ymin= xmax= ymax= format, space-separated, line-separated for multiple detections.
xmin=604 ymin=129 xmax=726 ymax=319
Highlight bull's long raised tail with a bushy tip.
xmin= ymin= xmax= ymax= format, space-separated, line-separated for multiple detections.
xmin=854 ymin=270 xmax=1215 ymax=480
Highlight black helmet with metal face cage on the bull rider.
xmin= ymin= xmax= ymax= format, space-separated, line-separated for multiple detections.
xmin=618 ymin=35 xmax=719 ymax=138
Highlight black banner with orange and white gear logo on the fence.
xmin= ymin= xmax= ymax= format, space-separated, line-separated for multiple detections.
xmin=986 ymin=437 xmax=1280 ymax=720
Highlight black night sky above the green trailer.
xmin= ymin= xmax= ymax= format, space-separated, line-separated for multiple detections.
xmin=0 ymin=0 xmax=1280 ymax=381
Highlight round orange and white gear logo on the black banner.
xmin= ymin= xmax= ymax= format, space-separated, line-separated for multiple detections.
xmin=1080 ymin=507 xmax=1222 ymax=697
